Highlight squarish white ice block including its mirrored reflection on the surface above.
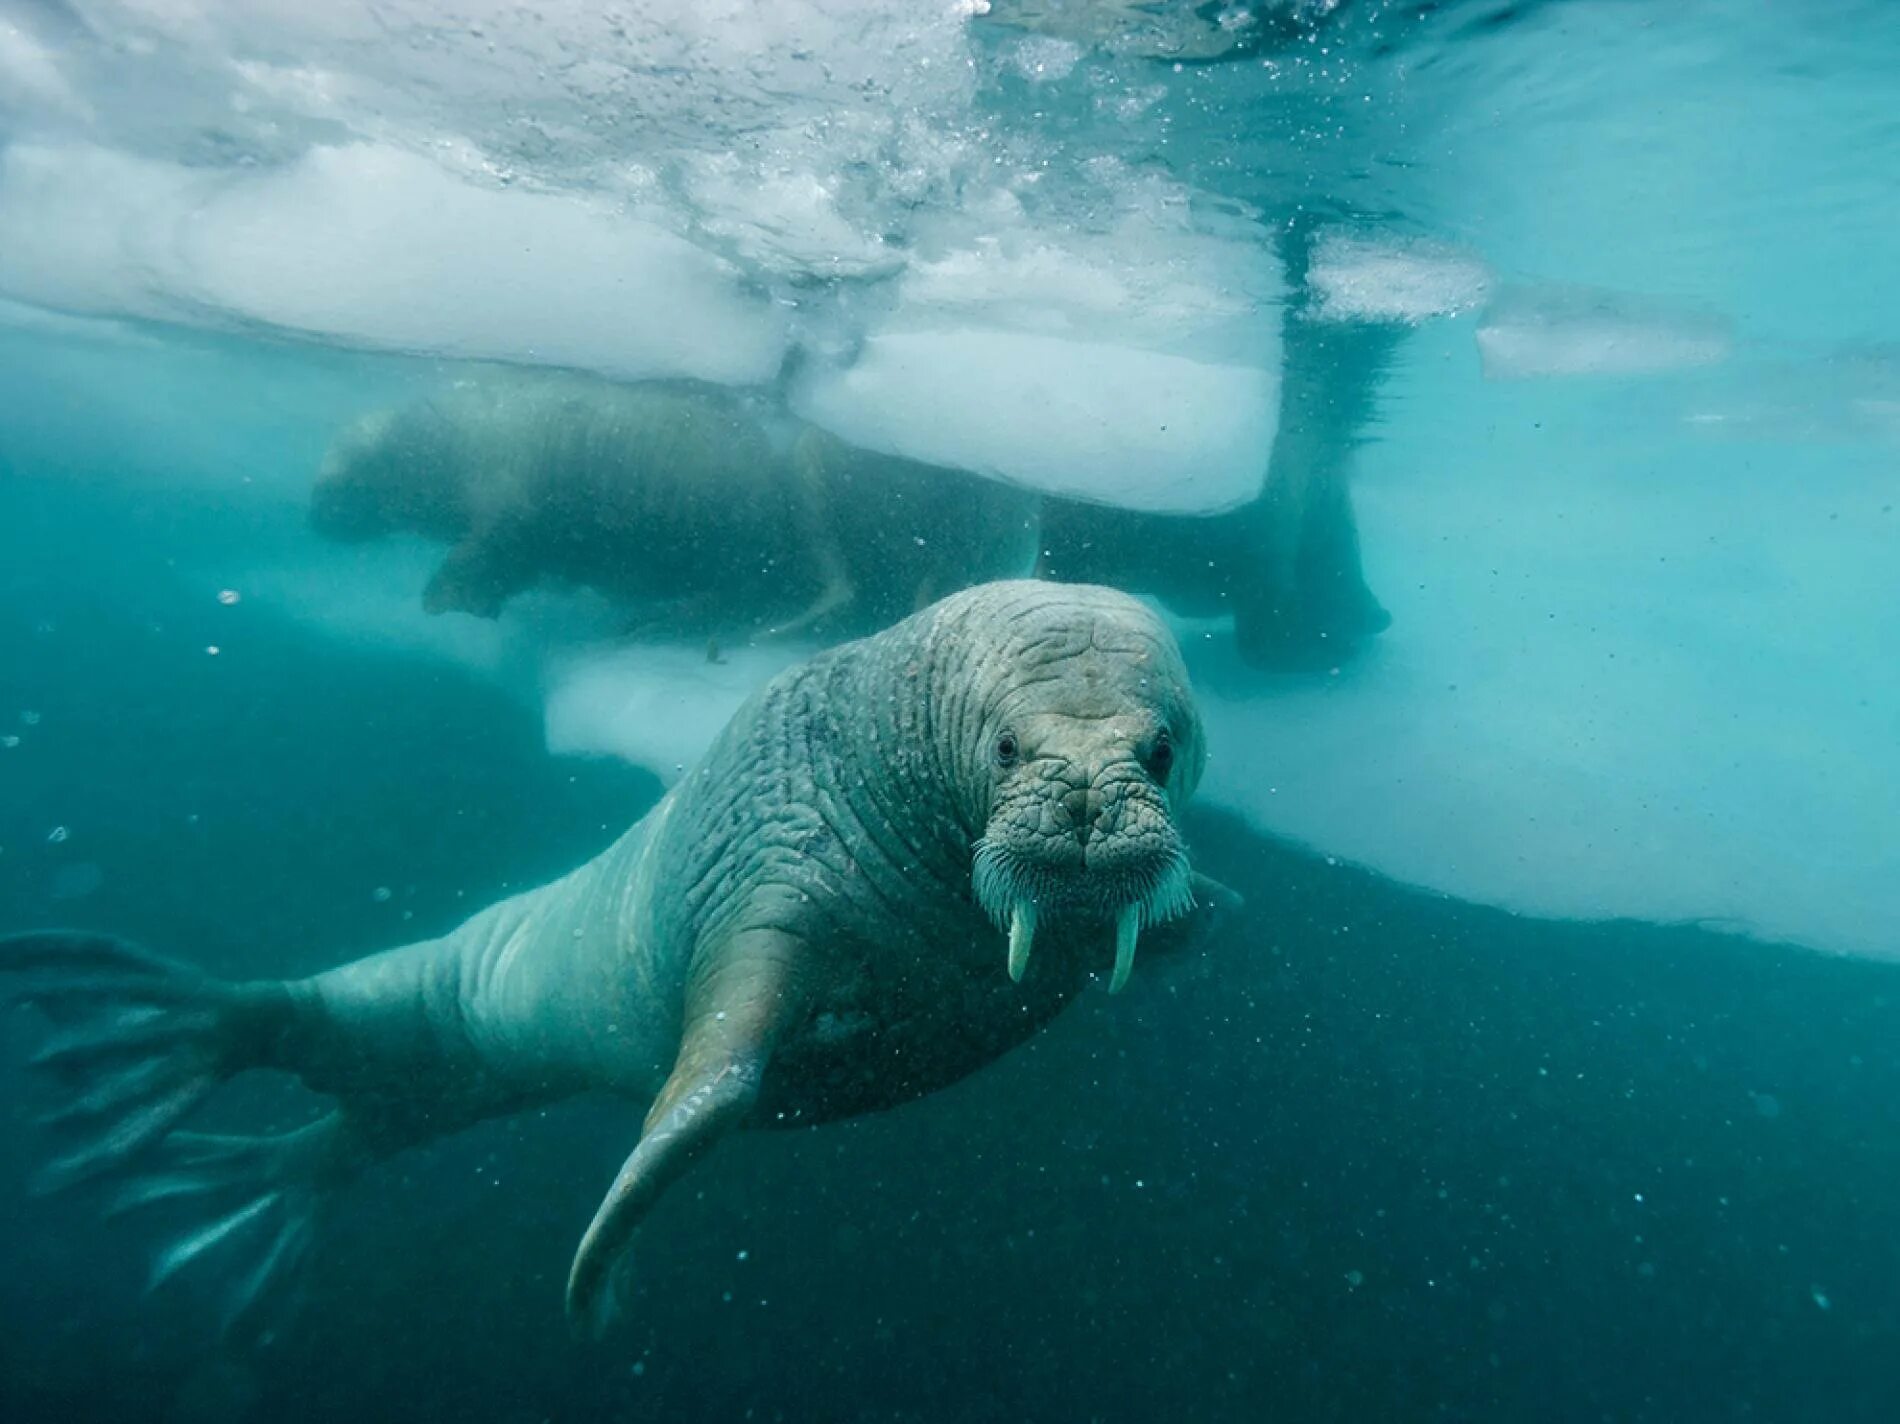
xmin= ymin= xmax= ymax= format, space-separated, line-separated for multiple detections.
xmin=792 ymin=195 xmax=1284 ymax=513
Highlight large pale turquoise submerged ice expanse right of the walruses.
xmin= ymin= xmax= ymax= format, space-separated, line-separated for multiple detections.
xmin=1189 ymin=333 xmax=1900 ymax=956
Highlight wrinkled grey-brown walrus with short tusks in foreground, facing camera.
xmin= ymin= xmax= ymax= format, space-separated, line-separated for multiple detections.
xmin=0 ymin=582 xmax=1237 ymax=1327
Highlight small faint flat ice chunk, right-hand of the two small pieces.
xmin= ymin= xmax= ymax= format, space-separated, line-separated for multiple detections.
xmin=1478 ymin=287 xmax=1733 ymax=380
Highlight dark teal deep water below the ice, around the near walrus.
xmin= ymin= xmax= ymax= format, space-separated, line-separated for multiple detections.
xmin=0 ymin=458 xmax=1900 ymax=1422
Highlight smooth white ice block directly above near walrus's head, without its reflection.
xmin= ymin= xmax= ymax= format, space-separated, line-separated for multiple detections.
xmin=792 ymin=329 xmax=1279 ymax=513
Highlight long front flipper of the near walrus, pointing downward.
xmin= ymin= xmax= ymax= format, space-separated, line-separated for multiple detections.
xmin=568 ymin=932 xmax=800 ymax=1335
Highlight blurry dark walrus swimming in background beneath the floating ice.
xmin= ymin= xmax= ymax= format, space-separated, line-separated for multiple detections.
xmin=310 ymin=355 xmax=1397 ymax=667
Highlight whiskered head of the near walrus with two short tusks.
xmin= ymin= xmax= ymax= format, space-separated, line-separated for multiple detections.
xmin=946 ymin=584 xmax=1207 ymax=991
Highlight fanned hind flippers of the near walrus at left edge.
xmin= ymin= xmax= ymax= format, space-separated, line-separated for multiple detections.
xmin=0 ymin=930 xmax=352 ymax=1333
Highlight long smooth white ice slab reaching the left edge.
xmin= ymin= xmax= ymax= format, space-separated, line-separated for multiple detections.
xmin=0 ymin=144 xmax=785 ymax=384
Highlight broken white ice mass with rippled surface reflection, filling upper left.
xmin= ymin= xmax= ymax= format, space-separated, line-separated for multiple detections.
xmin=0 ymin=0 xmax=1281 ymax=510
